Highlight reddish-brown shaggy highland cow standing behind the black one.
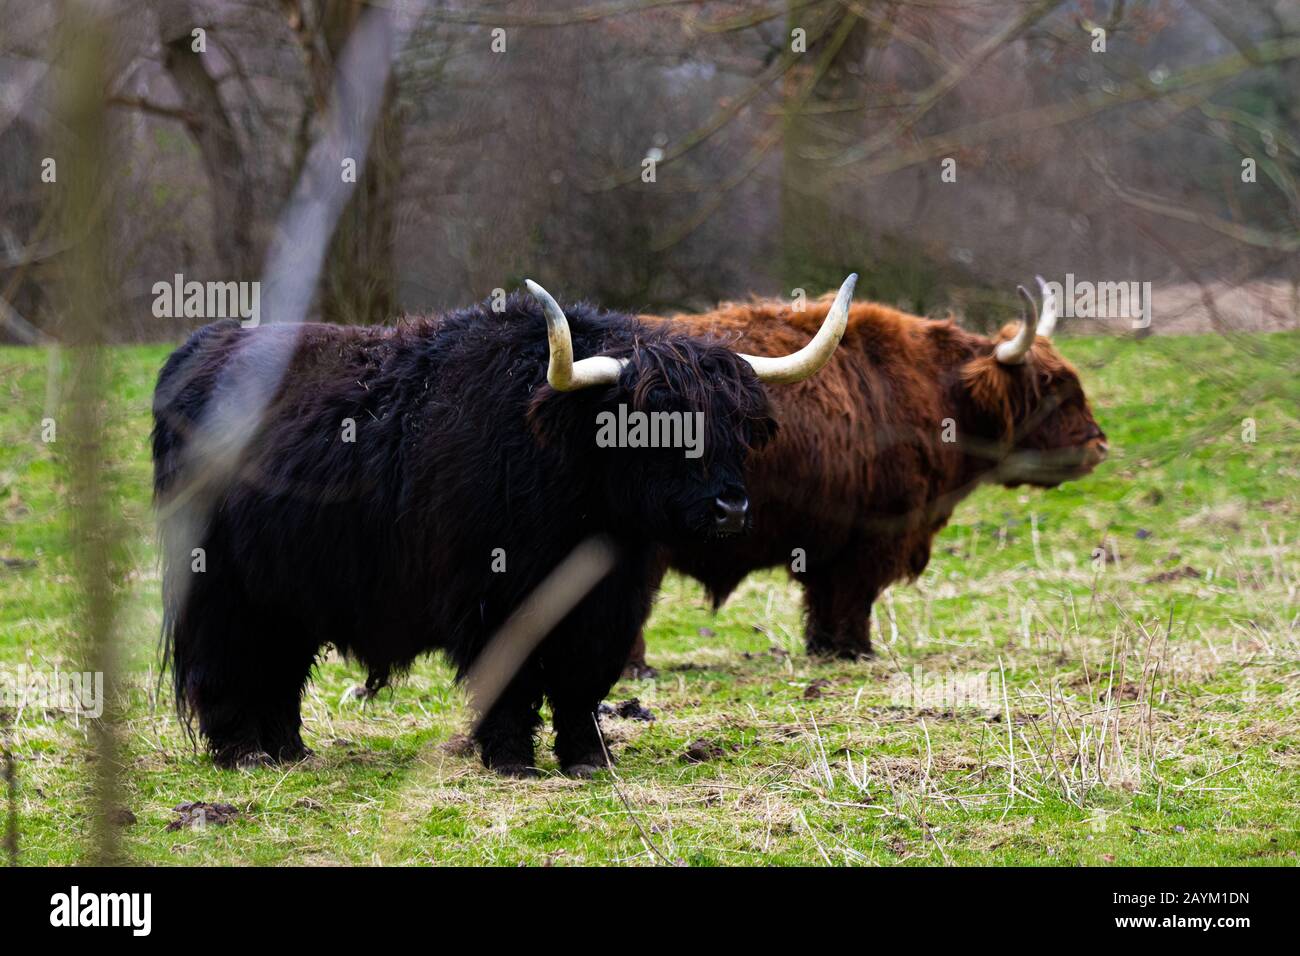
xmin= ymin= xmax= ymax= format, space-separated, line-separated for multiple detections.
xmin=629 ymin=297 xmax=1106 ymax=669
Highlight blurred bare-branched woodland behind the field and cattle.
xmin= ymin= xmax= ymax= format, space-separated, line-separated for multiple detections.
xmin=0 ymin=0 xmax=1300 ymax=342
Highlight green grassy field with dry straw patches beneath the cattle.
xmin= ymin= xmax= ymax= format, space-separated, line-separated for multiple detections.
xmin=0 ymin=333 xmax=1300 ymax=865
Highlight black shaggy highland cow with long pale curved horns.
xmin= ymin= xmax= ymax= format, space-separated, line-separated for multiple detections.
xmin=153 ymin=277 xmax=853 ymax=775
